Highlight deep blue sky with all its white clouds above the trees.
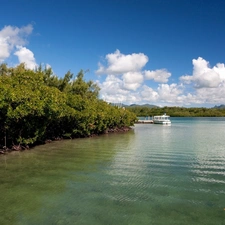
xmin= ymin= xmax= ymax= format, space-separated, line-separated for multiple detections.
xmin=0 ymin=0 xmax=225 ymax=107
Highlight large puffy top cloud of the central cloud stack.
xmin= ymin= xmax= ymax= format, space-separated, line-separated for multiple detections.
xmin=96 ymin=50 xmax=148 ymax=75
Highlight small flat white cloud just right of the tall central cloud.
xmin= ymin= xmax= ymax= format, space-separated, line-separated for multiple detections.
xmin=144 ymin=69 xmax=171 ymax=83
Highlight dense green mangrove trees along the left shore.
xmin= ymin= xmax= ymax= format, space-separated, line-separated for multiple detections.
xmin=0 ymin=64 xmax=136 ymax=149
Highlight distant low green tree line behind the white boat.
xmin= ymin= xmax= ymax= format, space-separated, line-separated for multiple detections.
xmin=126 ymin=106 xmax=225 ymax=117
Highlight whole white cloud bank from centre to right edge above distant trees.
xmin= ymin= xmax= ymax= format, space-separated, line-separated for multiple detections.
xmin=96 ymin=50 xmax=225 ymax=106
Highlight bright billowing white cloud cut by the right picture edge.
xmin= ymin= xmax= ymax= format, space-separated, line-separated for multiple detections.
xmin=180 ymin=57 xmax=225 ymax=88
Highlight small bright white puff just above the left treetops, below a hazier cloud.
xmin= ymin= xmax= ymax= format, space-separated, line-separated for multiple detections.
xmin=14 ymin=46 xmax=37 ymax=69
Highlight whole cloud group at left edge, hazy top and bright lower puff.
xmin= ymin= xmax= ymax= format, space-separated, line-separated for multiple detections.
xmin=0 ymin=24 xmax=36 ymax=69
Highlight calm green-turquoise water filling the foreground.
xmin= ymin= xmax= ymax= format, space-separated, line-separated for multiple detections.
xmin=0 ymin=118 xmax=225 ymax=225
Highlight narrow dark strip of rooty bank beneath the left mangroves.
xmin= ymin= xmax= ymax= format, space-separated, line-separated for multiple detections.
xmin=0 ymin=126 xmax=132 ymax=155
